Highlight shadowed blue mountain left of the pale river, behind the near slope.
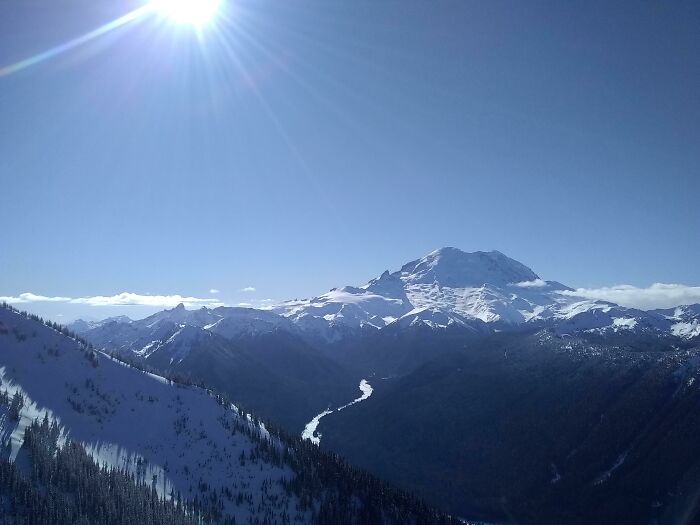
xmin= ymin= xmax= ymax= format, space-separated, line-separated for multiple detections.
xmin=68 ymin=305 xmax=361 ymax=432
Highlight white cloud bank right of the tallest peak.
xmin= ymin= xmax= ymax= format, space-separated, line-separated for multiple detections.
xmin=560 ymin=283 xmax=700 ymax=310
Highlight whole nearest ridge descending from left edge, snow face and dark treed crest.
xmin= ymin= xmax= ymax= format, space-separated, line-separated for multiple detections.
xmin=0 ymin=302 xmax=451 ymax=524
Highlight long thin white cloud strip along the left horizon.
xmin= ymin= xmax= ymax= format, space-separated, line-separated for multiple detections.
xmin=0 ymin=292 xmax=223 ymax=308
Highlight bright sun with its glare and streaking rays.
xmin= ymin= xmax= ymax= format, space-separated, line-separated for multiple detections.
xmin=0 ymin=0 xmax=360 ymax=218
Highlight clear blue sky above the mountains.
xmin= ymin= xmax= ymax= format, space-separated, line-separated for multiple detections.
xmin=0 ymin=0 xmax=700 ymax=317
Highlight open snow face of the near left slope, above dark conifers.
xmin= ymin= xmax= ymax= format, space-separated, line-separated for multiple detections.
xmin=0 ymin=308 xmax=309 ymax=522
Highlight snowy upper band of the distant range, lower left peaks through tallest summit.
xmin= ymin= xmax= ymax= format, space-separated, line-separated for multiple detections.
xmin=69 ymin=248 xmax=700 ymax=352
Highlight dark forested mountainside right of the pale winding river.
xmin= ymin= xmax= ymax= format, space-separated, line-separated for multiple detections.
xmin=319 ymin=329 xmax=700 ymax=525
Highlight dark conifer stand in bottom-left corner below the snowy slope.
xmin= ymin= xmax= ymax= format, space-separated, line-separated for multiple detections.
xmin=0 ymin=417 xmax=224 ymax=525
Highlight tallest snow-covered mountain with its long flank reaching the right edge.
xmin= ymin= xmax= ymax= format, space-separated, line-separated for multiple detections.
xmin=274 ymin=248 xmax=697 ymax=343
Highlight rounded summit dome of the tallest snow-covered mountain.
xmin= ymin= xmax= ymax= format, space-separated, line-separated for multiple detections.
xmin=400 ymin=247 xmax=539 ymax=288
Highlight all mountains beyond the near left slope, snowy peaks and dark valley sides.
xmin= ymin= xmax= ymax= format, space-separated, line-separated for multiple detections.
xmin=45 ymin=248 xmax=700 ymax=524
